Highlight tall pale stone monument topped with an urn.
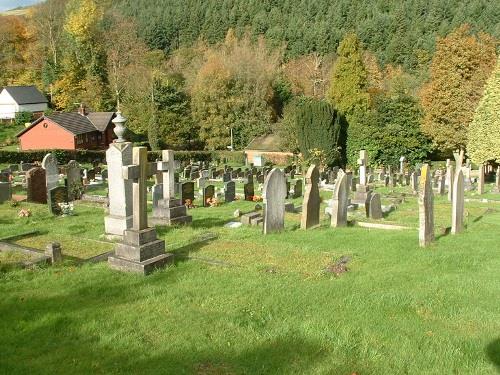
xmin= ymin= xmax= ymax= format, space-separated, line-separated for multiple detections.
xmin=104 ymin=112 xmax=133 ymax=236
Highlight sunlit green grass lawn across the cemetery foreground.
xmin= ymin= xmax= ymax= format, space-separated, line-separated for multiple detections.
xmin=0 ymin=181 xmax=500 ymax=374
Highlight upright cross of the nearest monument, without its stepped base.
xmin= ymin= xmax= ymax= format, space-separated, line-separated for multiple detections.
xmin=122 ymin=147 xmax=156 ymax=231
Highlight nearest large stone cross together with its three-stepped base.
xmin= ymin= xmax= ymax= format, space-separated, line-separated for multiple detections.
xmin=108 ymin=147 xmax=174 ymax=275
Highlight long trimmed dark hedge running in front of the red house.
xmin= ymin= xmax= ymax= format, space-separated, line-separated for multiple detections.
xmin=0 ymin=150 xmax=245 ymax=165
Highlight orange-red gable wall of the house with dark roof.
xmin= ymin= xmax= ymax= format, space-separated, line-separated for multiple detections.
xmin=19 ymin=119 xmax=75 ymax=151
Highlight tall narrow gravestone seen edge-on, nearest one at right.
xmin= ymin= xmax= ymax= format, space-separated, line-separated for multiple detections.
xmin=418 ymin=164 xmax=434 ymax=247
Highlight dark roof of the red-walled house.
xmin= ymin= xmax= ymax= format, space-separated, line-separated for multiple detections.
xmin=17 ymin=112 xmax=114 ymax=137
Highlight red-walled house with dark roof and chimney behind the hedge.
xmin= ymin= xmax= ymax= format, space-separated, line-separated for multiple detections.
xmin=17 ymin=106 xmax=115 ymax=151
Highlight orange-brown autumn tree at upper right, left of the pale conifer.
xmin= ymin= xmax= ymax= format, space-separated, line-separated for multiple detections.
xmin=420 ymin=25 xmax=496 ymax=165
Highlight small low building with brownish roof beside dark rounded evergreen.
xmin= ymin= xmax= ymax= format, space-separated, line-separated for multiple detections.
xmin=245 ymin=134 xmax=294 ymax=167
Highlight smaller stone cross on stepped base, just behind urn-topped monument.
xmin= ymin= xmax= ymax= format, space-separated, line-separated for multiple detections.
xmin=151 ymin=150 xmax=194 ymax=225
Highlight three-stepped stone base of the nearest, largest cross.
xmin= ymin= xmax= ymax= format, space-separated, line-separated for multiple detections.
xmin=108 ymin=228 xmax=174 ymax=275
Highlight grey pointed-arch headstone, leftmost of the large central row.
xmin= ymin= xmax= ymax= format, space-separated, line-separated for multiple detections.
xmin=262 ymin=168 xmax=286 ymax=234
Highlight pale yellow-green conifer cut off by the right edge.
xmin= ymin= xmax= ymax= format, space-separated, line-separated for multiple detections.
xmin=467 ymin=58 xmax=500 ymax=164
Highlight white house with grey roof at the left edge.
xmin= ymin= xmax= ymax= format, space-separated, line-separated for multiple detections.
xmin=0 ymin=86 xmax=48 ymax=119
